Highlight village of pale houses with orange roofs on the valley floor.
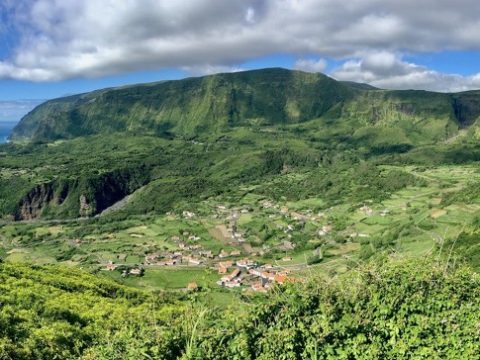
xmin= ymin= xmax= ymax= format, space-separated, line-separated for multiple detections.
xmin=100 ymin=200 xmax=382 ymax=292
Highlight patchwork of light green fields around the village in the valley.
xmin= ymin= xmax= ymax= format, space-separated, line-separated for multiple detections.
xmin=0 ymin=165 xmax=480 ymax=305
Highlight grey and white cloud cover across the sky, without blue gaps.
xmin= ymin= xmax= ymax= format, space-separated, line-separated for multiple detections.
xmin=0 ymin=0 xmax=480 ymax=90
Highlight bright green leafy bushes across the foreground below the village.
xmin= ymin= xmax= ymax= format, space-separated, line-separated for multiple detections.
xmin=0 ymin=259 xmax=480 ymax=359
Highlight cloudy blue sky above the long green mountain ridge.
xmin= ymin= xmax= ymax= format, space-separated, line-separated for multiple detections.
xmin=0 ymin=0 xmax=480 ymax=121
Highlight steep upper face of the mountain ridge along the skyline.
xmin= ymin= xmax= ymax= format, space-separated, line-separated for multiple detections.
xmin=11 ymin=68 xmax=480 ymax=144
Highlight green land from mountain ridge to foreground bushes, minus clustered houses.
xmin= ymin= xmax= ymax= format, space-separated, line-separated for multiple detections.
xmin=0 ymin=69 xmax=480 ymax=360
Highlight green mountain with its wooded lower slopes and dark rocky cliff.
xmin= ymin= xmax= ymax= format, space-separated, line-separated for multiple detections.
xmin=0 ymin=69 xmax=480 ymax=220
